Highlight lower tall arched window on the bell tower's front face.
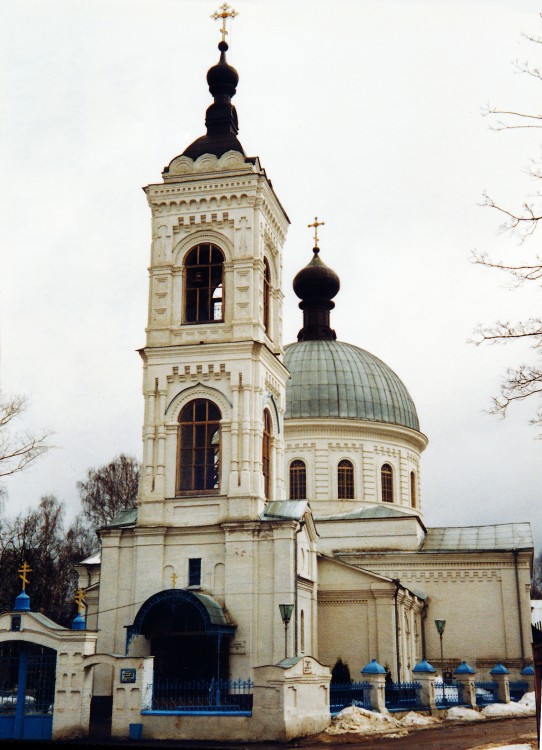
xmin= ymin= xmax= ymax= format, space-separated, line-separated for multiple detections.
xmin=177 ymin=398 xmax=221 ymax=492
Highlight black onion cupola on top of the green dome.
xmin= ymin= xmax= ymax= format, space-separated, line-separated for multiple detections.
xmin=293 ymin=247 xmax=341 ymax=341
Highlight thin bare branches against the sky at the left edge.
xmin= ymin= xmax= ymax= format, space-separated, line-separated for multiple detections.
xmin=0 ymin=393 xmax=50 ymax=497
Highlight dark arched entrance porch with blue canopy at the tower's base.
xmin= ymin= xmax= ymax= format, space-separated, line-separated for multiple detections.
xmin=127 ymin=589 xmax=235 ymax=681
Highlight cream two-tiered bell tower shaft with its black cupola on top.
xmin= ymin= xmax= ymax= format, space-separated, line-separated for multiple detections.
xmin=138 ymin=25 xmax=289 ymax=526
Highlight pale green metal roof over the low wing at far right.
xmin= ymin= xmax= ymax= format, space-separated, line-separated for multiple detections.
xmin=421 ymin=523 xmax=534 ymax=552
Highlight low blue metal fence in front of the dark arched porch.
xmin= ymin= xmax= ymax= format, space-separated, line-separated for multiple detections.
xmin=151 ymin=679 xmax=254 ymax=714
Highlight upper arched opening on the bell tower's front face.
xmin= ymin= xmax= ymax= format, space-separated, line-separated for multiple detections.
xmin=185 ymin=244 xmax=224 ymax=323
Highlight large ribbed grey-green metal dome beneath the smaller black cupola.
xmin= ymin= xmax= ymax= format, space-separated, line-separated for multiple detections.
xmin=284 ymin=340 xmax=420 ymax=431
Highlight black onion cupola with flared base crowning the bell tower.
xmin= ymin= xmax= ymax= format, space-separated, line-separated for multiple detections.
xmin=178 ymin=42 xmax=245 ymax=162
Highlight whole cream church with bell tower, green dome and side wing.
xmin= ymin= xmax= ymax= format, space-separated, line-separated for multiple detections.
xmin=0 ymin=8 xmax=533 ymax=748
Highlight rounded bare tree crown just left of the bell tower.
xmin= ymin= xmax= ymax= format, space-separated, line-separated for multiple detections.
xmin=77 ymin=453 xmax=139 ymax=528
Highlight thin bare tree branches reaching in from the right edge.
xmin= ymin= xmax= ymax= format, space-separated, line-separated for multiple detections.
xmin=473 ymin=19 xmax=542 ymax=425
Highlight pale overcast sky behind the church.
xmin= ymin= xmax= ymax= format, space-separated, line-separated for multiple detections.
xmin=0 ymin=0 xmax=542 ymax=548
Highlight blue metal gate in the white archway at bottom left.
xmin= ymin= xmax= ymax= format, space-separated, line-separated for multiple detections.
xmin=0 ymin=641 xmax=56 ymax=740
